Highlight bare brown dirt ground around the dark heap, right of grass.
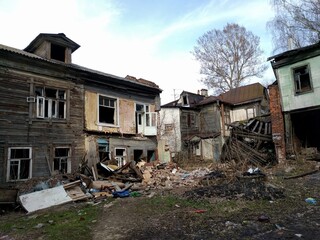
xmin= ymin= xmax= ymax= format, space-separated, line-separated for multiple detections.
xmin=93 ymin=163 xmax=320 ymax=240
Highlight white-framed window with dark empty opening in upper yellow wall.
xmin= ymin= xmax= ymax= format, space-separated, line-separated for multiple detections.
xmin=99 ymin=95 xmax=118 ymax=125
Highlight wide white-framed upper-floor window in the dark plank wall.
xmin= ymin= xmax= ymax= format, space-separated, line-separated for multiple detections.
xmin=35 ymin=87 xmax=67 ymax=119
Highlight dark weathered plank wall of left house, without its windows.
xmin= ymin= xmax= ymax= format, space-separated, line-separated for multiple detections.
xmin=0 ymin=69 xmax=84 ymax=182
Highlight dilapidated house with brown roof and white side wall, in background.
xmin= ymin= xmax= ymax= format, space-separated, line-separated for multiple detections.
xmin=159 ymin=83 xmax=269 ymax=161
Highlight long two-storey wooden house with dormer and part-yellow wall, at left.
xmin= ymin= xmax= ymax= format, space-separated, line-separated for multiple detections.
xmin=0 ymin=33 xmax=161 ymax=183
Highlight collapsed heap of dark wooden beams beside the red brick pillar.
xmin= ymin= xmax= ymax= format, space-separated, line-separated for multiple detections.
xmin=220 ymin=115 xmax=276 ymax=166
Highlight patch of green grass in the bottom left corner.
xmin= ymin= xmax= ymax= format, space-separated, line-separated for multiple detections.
xmin=0 ymin=202 xmax=100 ymax=240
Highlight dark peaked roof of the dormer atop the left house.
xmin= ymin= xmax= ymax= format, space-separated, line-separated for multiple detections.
xmin=24 ymin=33 xmax=80 ymax=53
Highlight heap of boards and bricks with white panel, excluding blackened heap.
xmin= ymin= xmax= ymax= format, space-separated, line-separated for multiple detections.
xmin=8 ymin=161 xmax=214 ymax=212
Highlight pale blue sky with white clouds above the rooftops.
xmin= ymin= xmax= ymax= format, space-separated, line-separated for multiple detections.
xmin=0 ymin=0 xmax=274 ymax=104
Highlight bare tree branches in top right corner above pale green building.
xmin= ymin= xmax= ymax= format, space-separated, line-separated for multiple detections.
xmin=267 ymin=0 xmax=320 ymax=53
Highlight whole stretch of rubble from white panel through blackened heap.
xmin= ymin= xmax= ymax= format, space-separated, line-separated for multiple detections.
xmin=1 ymin=153 xmax=292 ymax=212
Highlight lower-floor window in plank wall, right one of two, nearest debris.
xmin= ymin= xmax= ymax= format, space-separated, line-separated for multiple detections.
xmin=53 ymin=147 xmax=71 ymax=173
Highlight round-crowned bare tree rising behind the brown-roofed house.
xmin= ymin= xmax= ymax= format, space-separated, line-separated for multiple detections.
xmin=192 ymin=23 xmax=267 ymax=94
